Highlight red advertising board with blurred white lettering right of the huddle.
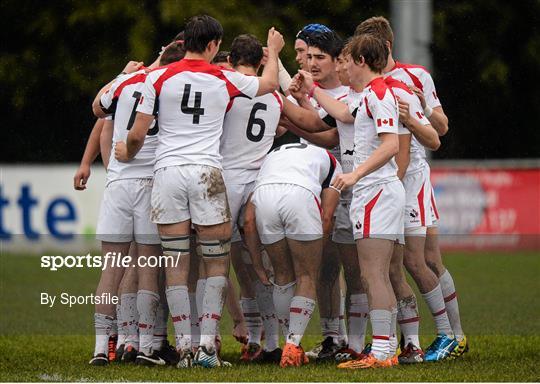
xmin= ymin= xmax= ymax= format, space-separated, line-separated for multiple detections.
xmin=431 ymin=168 xmax=540 ymax=249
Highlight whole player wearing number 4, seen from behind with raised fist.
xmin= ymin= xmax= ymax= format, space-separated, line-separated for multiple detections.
xmin=116 ymin=15 xmax=284 ymax=367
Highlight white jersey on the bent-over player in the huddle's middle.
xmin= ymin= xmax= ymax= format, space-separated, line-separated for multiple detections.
xmin=255 ymin=143 xmax=342 ymax=200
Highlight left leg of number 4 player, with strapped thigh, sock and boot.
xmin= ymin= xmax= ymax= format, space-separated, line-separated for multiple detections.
xmin=158 ymin=220 xmax=191 ymax=366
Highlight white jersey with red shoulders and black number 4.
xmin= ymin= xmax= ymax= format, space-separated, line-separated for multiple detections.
xmin=137 ymin=59 xmax=259 ymax=170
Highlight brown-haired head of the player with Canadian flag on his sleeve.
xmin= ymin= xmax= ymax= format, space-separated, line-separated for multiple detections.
xmin=346 ymin=34 xmax=388 ymax=83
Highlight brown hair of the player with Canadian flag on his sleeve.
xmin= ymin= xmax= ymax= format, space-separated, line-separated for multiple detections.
xmin=347 ymin=34 xmax=388 ymax=73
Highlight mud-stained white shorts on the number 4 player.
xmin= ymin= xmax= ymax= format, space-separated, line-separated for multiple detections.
xmin=152 ymin=164 xmax=231 ymax=225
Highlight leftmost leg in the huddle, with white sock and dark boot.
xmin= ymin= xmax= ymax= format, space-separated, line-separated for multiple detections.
xmin=90 ymin=241 xmax=130 ymax=365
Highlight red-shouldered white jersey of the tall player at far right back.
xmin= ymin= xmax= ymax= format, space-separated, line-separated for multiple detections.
xmin=385 ymin=61 xmax=441 ymax=108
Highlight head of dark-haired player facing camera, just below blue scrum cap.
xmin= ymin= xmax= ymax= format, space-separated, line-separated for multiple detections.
xmin=307 ymin=31 xmax=343 ymax=84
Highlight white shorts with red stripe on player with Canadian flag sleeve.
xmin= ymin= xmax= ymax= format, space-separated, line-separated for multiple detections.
xmin=350 ymin=180 xmax=405 ymax=244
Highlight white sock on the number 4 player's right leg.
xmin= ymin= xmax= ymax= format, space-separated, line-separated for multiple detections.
xmin=200 ymin=276 xmax=228 ymax=351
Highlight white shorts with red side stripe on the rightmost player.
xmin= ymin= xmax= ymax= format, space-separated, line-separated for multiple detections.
xmin=403 ymin=167 xmax=431 ymax=235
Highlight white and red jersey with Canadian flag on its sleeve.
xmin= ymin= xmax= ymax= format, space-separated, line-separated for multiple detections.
xmin=349 ymin=77 xmax=399 ymax=190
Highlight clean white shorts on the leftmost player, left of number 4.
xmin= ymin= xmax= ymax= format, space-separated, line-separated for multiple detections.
xmin=96 ymin=179 xmax=160 ymax=244
